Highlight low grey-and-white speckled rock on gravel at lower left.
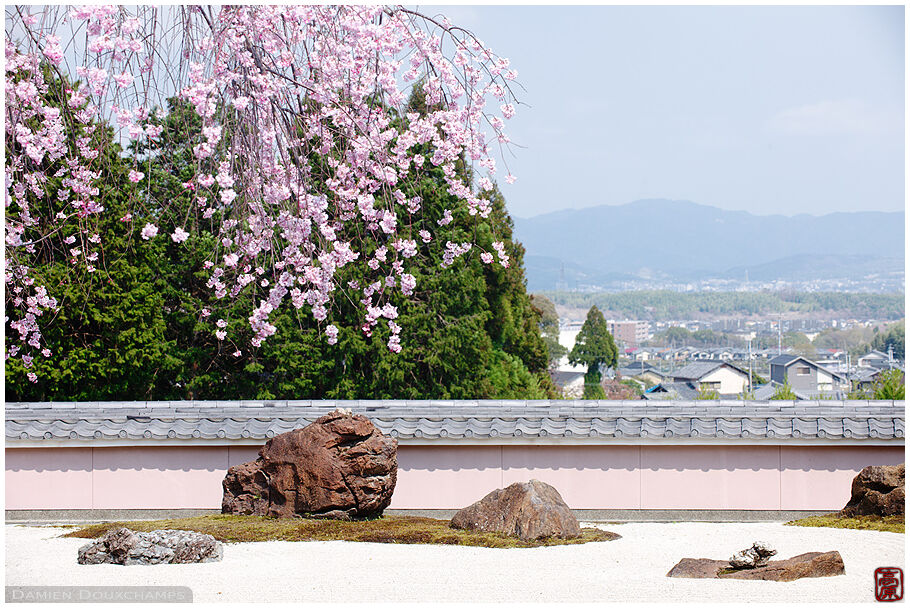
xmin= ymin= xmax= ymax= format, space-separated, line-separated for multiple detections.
xmin=78 ymin=528 xmax=224 ymax=566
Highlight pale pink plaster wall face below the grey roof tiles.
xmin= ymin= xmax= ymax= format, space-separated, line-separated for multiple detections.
xmin=6 ymin=445 xmax=904 ymax=511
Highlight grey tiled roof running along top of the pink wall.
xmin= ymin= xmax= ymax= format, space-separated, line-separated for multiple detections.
xmin=6 ymin=400 xmax=904 ymax=447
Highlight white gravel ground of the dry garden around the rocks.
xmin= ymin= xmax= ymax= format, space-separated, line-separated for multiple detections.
xmin=5 ymin=523 xmax=904 ymax=603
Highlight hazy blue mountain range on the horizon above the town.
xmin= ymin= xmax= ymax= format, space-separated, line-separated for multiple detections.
xmin=515 ymin=199 xmax=904 ymax=291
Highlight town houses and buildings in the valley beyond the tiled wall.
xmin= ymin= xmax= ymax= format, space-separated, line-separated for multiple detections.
xmin=551 ymin=309 xmax=905 ymax=400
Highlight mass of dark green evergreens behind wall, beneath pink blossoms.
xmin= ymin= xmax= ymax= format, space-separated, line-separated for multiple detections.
xmin=6 ymin=91 xmax=556 ymax=400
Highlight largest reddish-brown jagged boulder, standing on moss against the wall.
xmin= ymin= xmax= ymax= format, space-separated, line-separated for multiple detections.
xmin=221 ymin=410 xmax=398 ymax=519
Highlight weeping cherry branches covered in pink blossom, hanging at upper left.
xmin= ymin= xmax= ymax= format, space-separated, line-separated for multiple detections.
xmin=5 ymin=5 xmax=517 ymax=370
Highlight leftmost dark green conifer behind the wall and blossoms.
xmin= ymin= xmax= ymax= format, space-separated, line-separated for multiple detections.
xmin=5 ymin=72 xmax=181 ymax=401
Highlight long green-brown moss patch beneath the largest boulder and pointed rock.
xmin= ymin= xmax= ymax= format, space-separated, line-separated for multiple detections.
xmin=64 ymin=515 xmax=620 ymax=549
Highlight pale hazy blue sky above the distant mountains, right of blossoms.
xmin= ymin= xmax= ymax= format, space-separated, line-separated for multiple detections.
xmin=421 ymin=6 xmax=904 ymax=217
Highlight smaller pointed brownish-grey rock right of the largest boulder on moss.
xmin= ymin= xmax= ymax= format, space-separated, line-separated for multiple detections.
xmin=451 ymin=479 xmax=581 ymax=540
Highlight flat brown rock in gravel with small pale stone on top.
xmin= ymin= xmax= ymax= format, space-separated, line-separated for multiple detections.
xmin=667 ymin=551 xmax=845 ymax=582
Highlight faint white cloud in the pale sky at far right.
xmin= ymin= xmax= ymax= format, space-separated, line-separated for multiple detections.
xmin=767 ymin=99 xmax=904 ymax=135
